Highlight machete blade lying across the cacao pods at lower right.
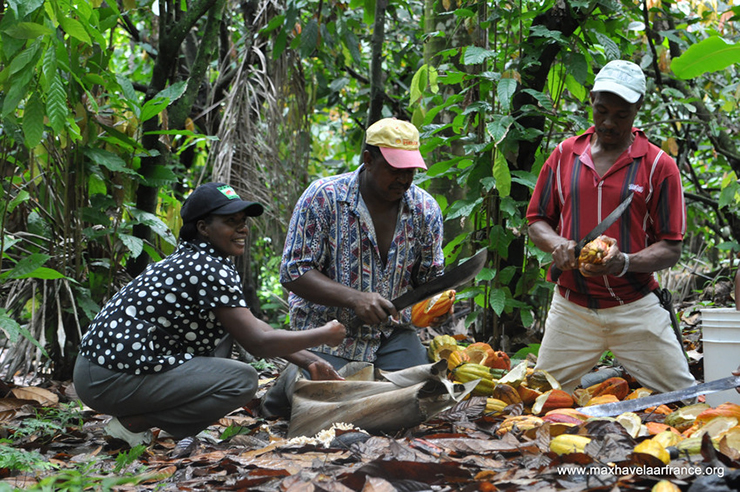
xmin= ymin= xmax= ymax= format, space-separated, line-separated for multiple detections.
xmin=576 ymin=376 xmax=740 ymax=417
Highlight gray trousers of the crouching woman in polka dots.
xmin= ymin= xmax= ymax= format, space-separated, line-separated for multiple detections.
xmin=74 ymin=343 xmax=258 ymax=439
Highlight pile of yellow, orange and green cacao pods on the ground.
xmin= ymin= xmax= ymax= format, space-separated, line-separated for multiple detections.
xmin=428 ymin=335 xmax=740 ymax=474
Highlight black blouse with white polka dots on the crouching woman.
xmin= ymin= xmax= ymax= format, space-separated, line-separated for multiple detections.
xmin=80 ymin=242 xmax=247 ymax=374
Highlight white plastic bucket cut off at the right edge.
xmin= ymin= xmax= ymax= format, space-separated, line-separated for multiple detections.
xmin=701 ymin=307 xmax=740 ymax=407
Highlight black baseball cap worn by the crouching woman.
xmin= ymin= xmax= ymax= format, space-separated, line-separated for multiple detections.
xmin=180 ymin=183 xmax=264 ymax=223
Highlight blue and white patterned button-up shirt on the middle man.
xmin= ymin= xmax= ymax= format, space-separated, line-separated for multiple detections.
xmin=280 ymin=167 xmax=444 ymax=362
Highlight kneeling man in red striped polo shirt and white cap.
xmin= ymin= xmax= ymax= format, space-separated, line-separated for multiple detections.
xmin=527 ymin=60 xmax=695 ymax=392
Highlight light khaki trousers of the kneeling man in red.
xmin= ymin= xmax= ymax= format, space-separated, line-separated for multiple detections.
xmin=537 ymin=288 xmax=696 ymax=392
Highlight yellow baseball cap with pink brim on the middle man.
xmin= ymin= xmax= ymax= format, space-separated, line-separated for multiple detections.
xmin=365 ymin=118 xmax=427 ymax=169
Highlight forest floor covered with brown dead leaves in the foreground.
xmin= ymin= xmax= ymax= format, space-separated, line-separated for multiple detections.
xmin=0 ymin=280 xmax=740 ymax=492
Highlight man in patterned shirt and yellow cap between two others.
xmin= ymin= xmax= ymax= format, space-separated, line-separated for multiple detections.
xmin=280 ymin=118 xmax=444 ymax=371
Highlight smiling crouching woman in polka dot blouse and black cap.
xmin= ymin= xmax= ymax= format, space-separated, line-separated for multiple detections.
xmin=74 ymin=183 xmax=345 ymax=446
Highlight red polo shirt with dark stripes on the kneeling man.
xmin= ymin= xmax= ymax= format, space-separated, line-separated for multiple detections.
xmin=527 ymin=127 xmax=686 ymax=308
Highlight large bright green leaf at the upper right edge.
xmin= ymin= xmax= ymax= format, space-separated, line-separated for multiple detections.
xmin=671 ymin=36 xmax=740 ymax=80
